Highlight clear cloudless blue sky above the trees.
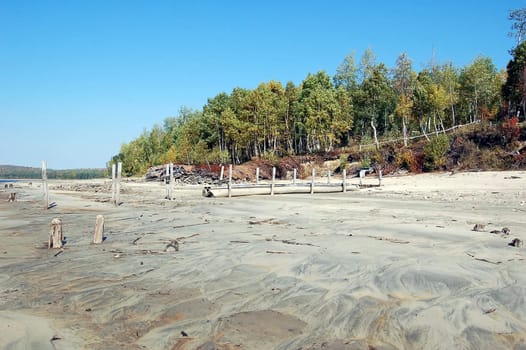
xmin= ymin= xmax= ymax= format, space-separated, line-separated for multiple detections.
xmin=0 ymin=0 xmax=526 ymax=169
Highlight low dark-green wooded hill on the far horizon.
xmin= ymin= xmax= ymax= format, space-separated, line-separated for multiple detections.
xmin=0 ymin=165 xmax=107 ymax=179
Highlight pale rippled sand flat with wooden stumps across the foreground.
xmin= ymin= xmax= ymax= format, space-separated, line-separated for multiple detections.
xmin=0 ymin=172 xmax=526 ymax=350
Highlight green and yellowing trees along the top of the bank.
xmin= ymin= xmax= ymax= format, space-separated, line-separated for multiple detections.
xmin=110 ymin=10 xmax=526 ymax=175
